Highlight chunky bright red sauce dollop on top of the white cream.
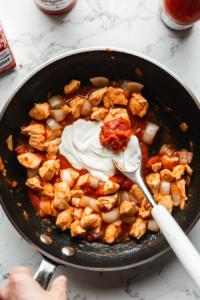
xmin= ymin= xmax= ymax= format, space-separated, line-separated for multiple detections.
xmin=99 ymin=117 xmax=135 ymax=152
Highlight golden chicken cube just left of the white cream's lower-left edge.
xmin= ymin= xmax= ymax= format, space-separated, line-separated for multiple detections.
xmin=39 ymin=160 xmax=60 ymax=181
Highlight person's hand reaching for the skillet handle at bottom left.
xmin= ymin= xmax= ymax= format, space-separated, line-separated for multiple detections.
xmin=0 ymin=267 xmax=67 ymax=300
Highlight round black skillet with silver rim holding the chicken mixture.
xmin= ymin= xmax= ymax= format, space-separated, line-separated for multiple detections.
xmin=0 ymin=48 xmax=200 ymax=286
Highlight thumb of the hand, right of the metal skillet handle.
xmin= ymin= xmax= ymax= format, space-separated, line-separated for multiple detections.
xmin=50 ymin=276 xmax=67 ymax=300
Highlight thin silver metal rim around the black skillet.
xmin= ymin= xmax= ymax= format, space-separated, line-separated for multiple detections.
xmin=0 ymin=47 xmax=200 ymax=272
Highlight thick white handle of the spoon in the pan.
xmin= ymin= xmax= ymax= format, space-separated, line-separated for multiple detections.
xmin=151 ymin=205 xmax=200 ymax=289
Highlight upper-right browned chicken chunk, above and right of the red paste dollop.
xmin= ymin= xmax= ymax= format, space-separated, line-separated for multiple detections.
xmin=129 ymin=93 xmax=149 ymax=118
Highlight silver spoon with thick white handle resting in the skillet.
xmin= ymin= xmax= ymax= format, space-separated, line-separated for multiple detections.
xmin=113 ymin=147 xmax=200 ymax=289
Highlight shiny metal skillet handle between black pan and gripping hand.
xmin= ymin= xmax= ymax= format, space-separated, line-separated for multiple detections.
xmin=33 ymin=257 xmax=57 ymax=290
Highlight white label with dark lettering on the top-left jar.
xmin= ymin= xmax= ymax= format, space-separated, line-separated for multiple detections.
xmin=35 ymin=0 xmax=73 ymax=11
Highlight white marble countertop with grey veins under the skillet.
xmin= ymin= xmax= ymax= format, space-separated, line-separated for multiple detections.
xmin=0 ymin=0 xmax=200 ymax=300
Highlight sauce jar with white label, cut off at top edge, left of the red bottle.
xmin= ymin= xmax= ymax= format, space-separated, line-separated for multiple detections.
xmin=35 ymin=0 xmax=77 ymax=15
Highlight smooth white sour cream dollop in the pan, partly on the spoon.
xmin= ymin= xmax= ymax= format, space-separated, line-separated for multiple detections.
xmin=59 ymin=119 xmax=140 ymax=181
